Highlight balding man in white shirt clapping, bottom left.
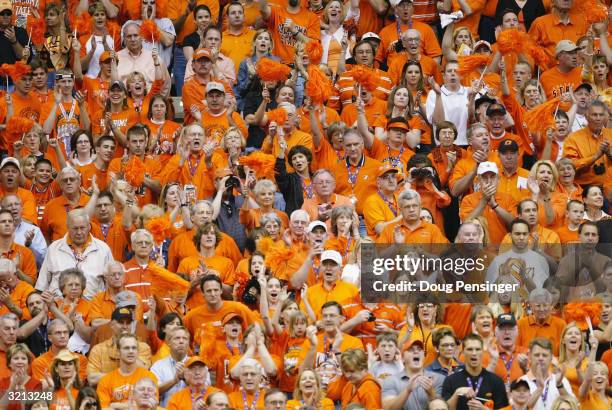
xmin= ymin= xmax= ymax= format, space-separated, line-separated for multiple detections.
xmin=151 ymin=327 xmax=189 ymax=408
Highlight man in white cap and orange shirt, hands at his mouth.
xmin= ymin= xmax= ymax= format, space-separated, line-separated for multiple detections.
xmin=459 ymin=161 xmax=516 ymax=243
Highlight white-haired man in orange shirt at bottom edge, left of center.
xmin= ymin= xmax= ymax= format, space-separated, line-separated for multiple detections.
xmin=229 ymin=358 xmax=266 ymax=409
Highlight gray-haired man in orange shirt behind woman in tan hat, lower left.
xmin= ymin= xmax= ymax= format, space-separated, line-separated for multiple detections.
xmin=32 ymin=319 xmax=87 ymax=380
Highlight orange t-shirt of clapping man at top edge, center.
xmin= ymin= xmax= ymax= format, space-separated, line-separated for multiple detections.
xmin=268 ymin=5 xmax=321 ymax=64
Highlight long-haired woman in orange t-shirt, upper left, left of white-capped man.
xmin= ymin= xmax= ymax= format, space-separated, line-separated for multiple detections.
xmin=144 ymin=94 xmax=181 ymax=163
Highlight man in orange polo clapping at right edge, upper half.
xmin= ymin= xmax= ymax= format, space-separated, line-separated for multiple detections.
xmin=563 ymin=100 xmax=612 ymax=186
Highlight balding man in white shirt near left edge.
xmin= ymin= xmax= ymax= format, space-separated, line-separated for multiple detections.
xmin=0 ymin=194 xmax=47 ymax=267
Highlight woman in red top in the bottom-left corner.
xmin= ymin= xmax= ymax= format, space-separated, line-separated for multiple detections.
xmin=0 ymin=343 xmax=46 ymax=410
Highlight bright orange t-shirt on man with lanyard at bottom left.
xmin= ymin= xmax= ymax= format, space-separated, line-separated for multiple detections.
xmin=96 ymin=367 xmax=157 ymax=408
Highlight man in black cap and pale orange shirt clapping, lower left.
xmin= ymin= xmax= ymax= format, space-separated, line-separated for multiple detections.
xmin=87 ymin=316 xmax=157 ymax=386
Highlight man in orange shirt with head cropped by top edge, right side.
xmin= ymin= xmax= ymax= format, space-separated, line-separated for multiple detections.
xmin=529 ymin=0 xmax=588 ymax=61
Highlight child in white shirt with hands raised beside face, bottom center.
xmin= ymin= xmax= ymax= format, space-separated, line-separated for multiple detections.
xmin=368 ymin=333 xmax=404 ymax=383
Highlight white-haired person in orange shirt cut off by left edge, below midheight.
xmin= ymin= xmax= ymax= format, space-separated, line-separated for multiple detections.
xmin=0 ymin=258 xmax=34 ymax=318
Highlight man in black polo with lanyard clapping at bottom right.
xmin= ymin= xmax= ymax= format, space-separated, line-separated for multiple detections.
xmin=442 ymin=334 xmax=508 ymax=410
